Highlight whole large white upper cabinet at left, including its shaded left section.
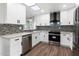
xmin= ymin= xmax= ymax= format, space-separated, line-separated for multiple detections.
xmin=0 ymin=3 xmax=26 ymax=24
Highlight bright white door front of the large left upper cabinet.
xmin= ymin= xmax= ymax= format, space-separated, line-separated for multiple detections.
xmin=6 ymin=3 xmax=26 ymax=24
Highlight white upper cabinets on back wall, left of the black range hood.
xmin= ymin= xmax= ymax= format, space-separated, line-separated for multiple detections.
xmin=34 ymin=14 xmax=50 ymax=26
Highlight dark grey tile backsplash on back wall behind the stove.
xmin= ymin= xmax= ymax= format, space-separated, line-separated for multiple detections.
xmin=37 ymin=25 xmax=75 ymax=32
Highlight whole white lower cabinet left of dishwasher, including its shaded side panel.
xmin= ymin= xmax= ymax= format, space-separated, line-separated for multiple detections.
xmin=0 ymin=37 xmax=22 ymax=56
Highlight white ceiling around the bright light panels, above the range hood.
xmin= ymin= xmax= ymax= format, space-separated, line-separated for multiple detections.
xmin=26 ymin=3 xmax=76 ymax=18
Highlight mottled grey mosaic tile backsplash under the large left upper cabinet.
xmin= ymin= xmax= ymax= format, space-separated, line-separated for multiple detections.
xmin=0 ymin=24 xmax=23 ymax=35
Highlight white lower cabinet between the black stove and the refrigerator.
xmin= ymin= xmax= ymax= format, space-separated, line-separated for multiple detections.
xmin=60 ymin=32 xmax=73 ymax=50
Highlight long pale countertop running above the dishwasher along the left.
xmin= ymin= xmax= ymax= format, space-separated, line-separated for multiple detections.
xmin=0 ymin=30 xmax=47 ymax=39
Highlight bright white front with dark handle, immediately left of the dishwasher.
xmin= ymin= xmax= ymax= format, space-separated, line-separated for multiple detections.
xmin=10 ymin=37 xmax=22 ymax=56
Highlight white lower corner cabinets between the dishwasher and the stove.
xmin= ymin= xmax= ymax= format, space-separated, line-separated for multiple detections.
xmin=32 ymin=31 xmax=48 ymax=47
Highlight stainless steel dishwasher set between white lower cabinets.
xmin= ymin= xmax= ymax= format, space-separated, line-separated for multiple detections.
xmin=21 ymin=34 xmax=32 ymax=56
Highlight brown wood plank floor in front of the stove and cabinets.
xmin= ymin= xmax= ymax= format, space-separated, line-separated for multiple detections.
xmin=26 ymin=43 xmax=79 ymax=56
